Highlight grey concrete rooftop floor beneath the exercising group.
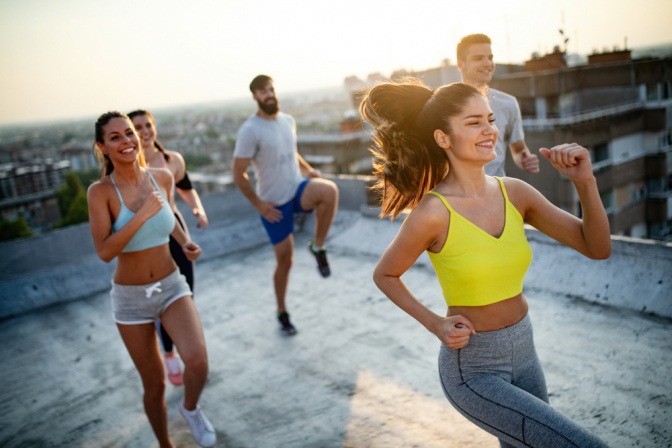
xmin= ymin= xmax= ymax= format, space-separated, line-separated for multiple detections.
xmin=0 ymin=213 xmax=672 ymax=448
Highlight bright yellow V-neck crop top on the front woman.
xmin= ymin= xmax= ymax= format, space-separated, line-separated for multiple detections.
xmin=427 ymin=178 xmax=532 ymax=306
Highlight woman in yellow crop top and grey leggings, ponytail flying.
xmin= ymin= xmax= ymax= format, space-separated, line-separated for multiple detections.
xmin=360 ymin=81 xmax=611 ymax=448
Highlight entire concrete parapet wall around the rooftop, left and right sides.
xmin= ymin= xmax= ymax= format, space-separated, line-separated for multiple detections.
xmin=0 ymin=176 xmax=672 ymax=319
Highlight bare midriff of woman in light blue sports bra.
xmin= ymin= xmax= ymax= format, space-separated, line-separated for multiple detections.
xmin=114 ymin=244 xmax=177 ymax=285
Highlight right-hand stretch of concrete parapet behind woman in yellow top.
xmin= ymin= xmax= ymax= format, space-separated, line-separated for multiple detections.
xmin=330 ymin=217 xmax=672 ymax=318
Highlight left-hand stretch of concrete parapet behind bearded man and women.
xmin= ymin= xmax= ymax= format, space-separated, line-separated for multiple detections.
xmin=0 ymin=176 xmax=368 ymax=320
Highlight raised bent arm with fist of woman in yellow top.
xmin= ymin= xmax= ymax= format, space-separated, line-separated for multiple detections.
xmin=523 ymin=143 xmax=611 ymax=259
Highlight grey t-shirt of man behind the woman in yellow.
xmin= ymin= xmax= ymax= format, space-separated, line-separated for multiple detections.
xmin=485 ymin=88 xmax=525 ymax=177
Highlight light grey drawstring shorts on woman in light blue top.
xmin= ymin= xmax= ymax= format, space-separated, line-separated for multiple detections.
xmin=110 ymin=269 xmax=191 ymax=325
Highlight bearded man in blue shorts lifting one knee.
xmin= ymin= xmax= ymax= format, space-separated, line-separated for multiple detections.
xmin=233 ymin=75 xmax=338 ymax=336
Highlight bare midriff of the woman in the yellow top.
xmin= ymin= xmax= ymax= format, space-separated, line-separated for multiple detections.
xmin=448 ymin=293 xmax=527 ymax=333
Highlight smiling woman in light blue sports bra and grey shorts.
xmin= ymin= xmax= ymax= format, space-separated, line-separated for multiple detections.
xmin=87 ymin=112 xmax=216 ymax=446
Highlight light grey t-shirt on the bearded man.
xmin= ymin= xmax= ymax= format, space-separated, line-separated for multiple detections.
xmin=233 ymin=112 xmax=303 ymax=205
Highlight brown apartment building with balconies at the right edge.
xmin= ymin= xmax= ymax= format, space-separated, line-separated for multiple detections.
xmin=492 ymin=50 xmax=672 ymax=240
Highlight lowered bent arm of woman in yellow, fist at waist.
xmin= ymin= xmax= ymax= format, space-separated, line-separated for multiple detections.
xmin=373 ymin=197 xmax=474 ymax=349
